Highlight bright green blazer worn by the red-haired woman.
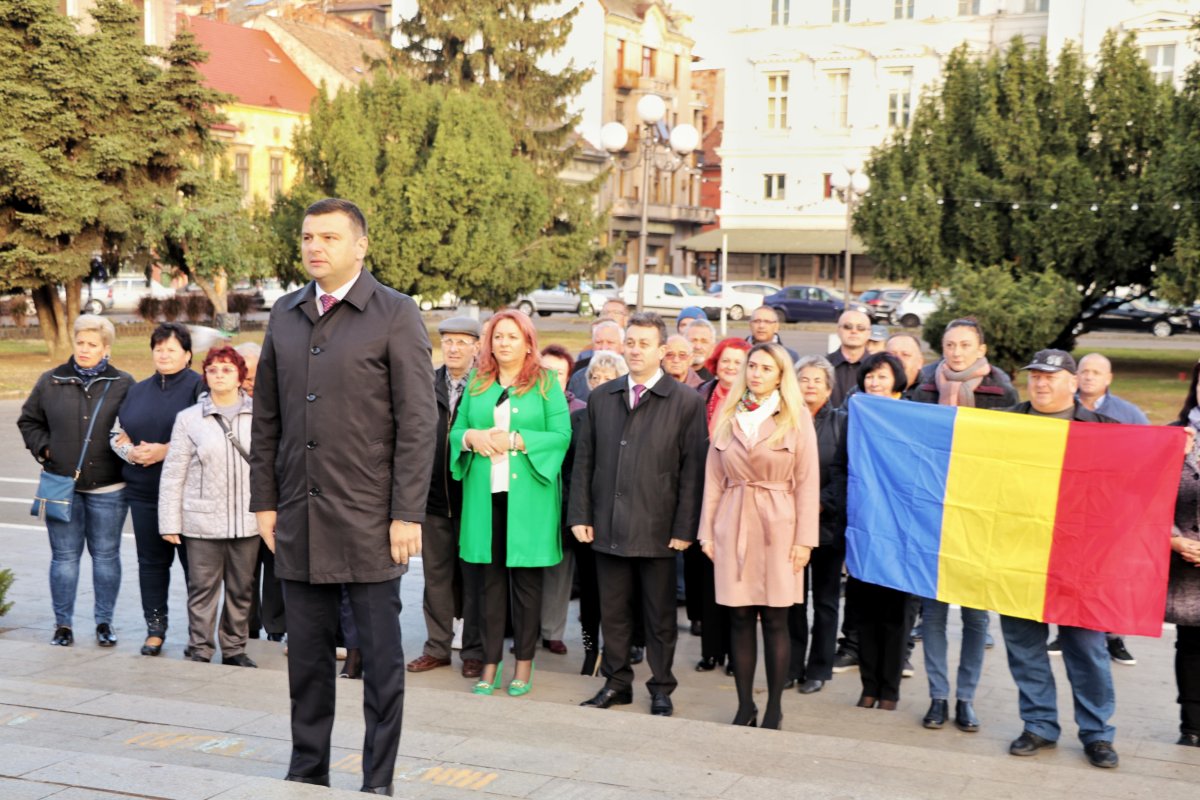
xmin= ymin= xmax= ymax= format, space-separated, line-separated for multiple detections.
xmin=450 ymin=371 xmax=571 ymax=567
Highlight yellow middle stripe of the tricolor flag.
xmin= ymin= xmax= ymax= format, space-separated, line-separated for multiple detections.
xmin=937 ymin=408 xmax=1070 ymax=619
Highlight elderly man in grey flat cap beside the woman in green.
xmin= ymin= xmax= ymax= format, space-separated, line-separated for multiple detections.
xmin=408 ymin=317 xmax=484 ymax=678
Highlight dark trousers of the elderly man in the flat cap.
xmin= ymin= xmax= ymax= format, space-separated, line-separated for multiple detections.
xmin=421 ymin=513 xmax=484 ymax=660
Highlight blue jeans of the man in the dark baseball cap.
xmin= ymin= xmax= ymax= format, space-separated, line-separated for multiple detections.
xmin=1000 ymin=615 xmax=1117 ymax=745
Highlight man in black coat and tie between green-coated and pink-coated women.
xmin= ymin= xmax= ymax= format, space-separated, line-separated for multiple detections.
xmin=568 ymin=313 xmax=708 ymax=716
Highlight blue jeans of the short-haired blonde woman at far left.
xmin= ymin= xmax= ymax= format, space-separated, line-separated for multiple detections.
xmin=46 ymin=489 xmax=128 ymax=627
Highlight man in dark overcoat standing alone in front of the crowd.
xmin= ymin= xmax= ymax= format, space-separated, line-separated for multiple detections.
xmin=250 ymin=199 xmax=438 ymax=795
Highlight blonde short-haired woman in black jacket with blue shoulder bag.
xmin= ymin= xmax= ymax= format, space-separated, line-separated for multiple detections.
xmin=17 ymin=314 xmax=133 ymax=648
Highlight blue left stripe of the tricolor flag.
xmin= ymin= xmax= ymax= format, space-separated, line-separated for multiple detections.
xmin=846 ymin=393 xmax=956 ymax=597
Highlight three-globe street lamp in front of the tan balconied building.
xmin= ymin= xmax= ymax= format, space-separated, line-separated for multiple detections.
xmin=600 ymin=95 xmax=700 ymax=311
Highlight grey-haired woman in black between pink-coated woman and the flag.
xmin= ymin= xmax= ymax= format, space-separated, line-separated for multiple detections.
xmin=787 ymin=356 xmax=846 ymax=694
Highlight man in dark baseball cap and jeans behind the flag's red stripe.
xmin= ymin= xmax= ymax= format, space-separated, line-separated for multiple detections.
xmin=1000 ymin=350 xmax=1118 ymax=768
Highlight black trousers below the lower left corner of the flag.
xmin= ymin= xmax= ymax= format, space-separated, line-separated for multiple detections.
xmin=846 ymin=578 xmax=912 ymax=700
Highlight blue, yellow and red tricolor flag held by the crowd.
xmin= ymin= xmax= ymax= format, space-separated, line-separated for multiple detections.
xmin=846 ymin=395 xmax=1186 ymax=636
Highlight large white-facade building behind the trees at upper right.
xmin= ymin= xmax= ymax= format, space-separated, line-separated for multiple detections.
xmin=684 ymin=0 xmax=1200 ymax=291
